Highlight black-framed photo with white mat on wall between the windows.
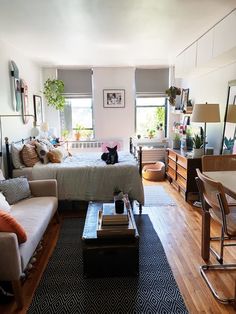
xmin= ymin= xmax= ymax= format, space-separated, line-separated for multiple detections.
xmin=103 ymin=89 xmax=125 ymax=108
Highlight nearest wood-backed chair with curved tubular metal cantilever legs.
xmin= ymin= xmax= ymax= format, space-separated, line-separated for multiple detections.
xmin=196 ymin=169 xmax=236 ymax=306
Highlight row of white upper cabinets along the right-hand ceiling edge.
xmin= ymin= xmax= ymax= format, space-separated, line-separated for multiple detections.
xmin=175 ymin=10 xmax=236 ymax=78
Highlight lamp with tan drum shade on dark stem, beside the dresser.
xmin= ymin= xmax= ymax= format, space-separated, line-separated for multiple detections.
xmin=191 ymin=103 xmax=220 ymax=154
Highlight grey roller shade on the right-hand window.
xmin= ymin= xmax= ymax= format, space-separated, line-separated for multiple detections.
xmin=135 ymin=68 xmax=169 ymax=94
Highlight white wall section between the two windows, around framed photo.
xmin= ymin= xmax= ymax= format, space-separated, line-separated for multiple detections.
xmin=93 ymin=67 xmax=135 ymax=149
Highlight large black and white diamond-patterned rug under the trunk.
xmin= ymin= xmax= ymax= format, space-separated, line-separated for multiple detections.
xmin=28 ymin=215 xmax=188 ymax=314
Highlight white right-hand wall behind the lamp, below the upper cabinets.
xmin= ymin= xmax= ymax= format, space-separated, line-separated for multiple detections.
xmin=182 ymin=63 xmax=236 ymax=153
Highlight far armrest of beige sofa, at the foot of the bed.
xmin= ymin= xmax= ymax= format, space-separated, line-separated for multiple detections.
xmin=29 ymin=179 xmax=57 ymax=197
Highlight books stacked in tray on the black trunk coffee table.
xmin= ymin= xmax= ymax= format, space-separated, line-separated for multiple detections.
xmin=97 ymin=203 xmax=135 ymax=237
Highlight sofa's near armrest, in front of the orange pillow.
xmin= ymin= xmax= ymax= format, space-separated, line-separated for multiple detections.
xmin=0 ymin=232 xmax=22 ymax=281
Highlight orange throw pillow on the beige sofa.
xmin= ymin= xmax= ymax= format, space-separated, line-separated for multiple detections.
xmin=0 ymin=210 xmax=27 ymax=243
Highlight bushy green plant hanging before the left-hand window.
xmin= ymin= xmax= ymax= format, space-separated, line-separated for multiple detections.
xmin=43 ymin=79 xmax=65 ymax=111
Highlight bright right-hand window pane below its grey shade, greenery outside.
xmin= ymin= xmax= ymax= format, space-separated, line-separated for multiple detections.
xmin=136 ymin=96 xmax=167 ymax=137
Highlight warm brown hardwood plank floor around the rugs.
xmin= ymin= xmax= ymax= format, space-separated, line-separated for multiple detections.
xmin=0 ymin=182 xmax=236 ymax=314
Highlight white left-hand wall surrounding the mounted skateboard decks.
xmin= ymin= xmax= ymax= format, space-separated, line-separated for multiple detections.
xmin=0 ymin=41 xmax=42 ymax=156
